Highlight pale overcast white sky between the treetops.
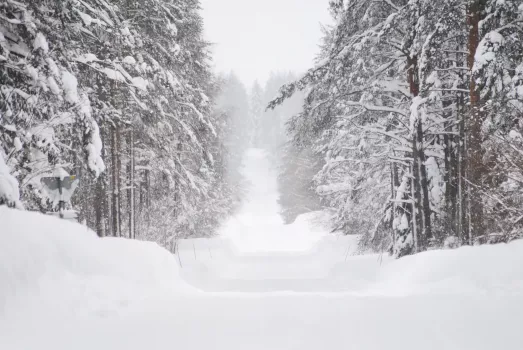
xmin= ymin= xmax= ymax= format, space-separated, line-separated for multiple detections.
xmin=201 ymin=0 xmax=330 ymax=86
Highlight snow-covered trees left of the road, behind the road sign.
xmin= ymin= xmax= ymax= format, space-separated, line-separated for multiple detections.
xmin=0 ymin=0 xmax=241 ymax=246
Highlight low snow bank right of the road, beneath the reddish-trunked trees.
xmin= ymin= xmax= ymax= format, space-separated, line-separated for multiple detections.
xmin=330 ymin=241 xmax=523 ymax=296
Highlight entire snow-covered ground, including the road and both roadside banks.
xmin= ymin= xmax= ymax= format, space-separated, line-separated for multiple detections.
xmin=0 ymin=150 xmax=523 ymax=350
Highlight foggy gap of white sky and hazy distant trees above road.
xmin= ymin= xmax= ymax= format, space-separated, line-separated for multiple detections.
xmin=202 ymin=0 xmax=331 ymax=223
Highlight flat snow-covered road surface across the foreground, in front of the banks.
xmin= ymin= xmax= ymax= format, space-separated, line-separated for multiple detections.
xmin=12 ymin=293 xmax=523 ymax=350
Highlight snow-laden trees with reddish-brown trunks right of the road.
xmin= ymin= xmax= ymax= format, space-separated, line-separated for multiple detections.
xmin=269 ymin=0 xmax=523 ymax=257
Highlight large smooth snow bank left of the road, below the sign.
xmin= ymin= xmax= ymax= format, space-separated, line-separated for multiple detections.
xmin=0 ymin=206 xmax=191 ymax=318
